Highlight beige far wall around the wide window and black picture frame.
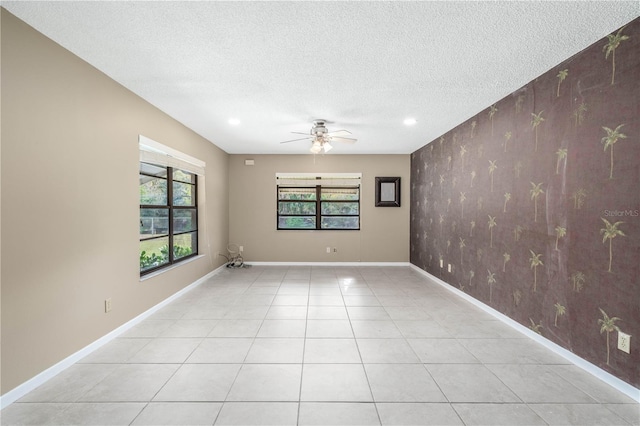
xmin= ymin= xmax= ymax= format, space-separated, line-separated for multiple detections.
xmin=229 ymin=155 xmax=410 ymax=262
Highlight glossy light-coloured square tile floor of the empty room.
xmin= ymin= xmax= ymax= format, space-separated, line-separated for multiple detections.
xmin=1 ymin=266 xmax=640 ymax=425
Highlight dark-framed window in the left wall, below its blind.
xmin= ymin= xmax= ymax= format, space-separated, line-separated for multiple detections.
xmin=140 ymin=162 xmax=198 ymax=275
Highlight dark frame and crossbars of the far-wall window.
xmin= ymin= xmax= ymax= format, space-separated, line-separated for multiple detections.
xmin=276 ymin=185 xmax=361 ymax=231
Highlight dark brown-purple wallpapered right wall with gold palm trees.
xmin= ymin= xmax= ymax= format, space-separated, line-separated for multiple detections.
xmin=411 ymin=18 xmax=640 ymax=387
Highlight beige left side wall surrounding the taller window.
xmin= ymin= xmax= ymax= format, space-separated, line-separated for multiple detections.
xmin=1 ymin=10 xmax=229 ymax=394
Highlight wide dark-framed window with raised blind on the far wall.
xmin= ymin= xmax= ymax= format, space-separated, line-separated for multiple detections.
xmin=277 ymin=176 xmax=360 ymax=230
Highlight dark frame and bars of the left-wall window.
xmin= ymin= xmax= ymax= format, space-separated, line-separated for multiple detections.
xmin=138 ymin=161 xmax=200 ymax=277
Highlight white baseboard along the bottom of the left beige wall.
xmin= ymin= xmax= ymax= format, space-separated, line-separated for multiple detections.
xmin=0 ymin=265 xmax=226 ymax=410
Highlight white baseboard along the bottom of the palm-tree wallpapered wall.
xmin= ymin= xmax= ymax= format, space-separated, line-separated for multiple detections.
xmin=411 ymin=264 xmax=640 ymax=402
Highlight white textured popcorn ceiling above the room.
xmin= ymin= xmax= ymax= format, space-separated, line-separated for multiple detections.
xmin=2 ymin=0 xmax=640 ymax=155
